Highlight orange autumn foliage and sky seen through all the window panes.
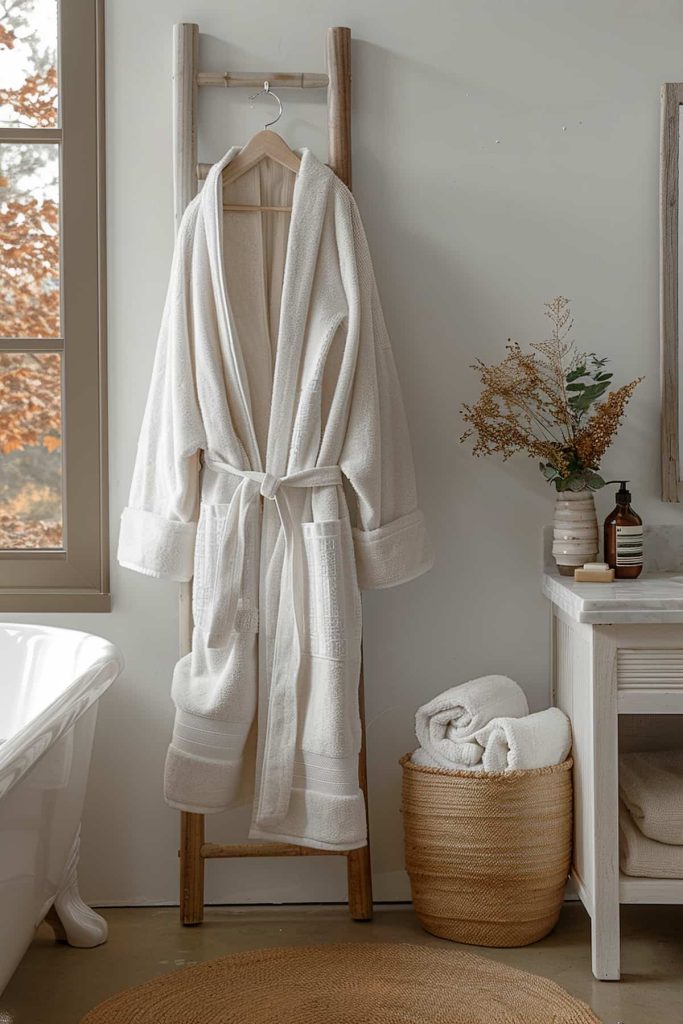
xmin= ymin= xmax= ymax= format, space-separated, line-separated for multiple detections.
xmin=0 ymin=0 xmax=62 ymax=550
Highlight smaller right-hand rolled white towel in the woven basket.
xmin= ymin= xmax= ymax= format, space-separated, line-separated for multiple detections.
xmin=475 ymin=708 xmax=571 ymax=771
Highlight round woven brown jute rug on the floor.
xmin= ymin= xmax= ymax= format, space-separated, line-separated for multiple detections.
xmin=81 ymin=942 xmax=600 ymax=1024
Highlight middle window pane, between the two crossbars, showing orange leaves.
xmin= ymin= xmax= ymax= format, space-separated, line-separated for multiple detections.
xmin=0 ymin=142 xmax=60 ymax=338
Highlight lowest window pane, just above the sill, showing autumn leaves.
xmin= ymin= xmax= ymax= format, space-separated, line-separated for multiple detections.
xmin=0 ymin=352 xmax=62 ymax=550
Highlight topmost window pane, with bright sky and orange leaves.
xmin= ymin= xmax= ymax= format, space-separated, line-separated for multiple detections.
xmin=0 ymin=0 xmax=57 ymax=128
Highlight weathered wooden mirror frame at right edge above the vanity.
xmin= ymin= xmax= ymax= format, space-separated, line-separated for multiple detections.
xmin=659 ymin=82 xmax=683 ymax=502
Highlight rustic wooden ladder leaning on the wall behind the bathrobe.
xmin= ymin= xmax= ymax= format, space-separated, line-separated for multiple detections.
xmin=173 ymin=24 xmax=373 ymax=925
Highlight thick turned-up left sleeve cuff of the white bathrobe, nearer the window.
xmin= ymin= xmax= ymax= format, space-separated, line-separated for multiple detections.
xmin=118 ymin=508 xmax=197 ymax=583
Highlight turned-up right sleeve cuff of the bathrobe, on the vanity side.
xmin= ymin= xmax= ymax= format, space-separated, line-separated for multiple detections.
xmin=353 ymin=509 xmax=434 ymax=590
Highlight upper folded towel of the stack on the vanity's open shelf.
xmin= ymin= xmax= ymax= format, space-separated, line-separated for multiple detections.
xmin=618 ymin=751 xmax=683 ymax=846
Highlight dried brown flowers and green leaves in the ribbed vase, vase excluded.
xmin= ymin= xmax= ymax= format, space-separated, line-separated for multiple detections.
xmin=460 ymin=296 xmax=642 ymax=490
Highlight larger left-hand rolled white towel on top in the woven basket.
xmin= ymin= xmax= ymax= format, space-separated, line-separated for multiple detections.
xmin=415 ymin=676 xmax=528 ymax=768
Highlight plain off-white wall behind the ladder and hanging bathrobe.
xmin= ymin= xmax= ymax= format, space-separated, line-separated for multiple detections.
xmin=9 ymin=0 xmax=683 ymax=903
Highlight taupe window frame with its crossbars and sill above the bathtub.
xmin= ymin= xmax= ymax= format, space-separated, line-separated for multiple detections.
xmin=0 ymin=0 xmax=111 ymax=612
